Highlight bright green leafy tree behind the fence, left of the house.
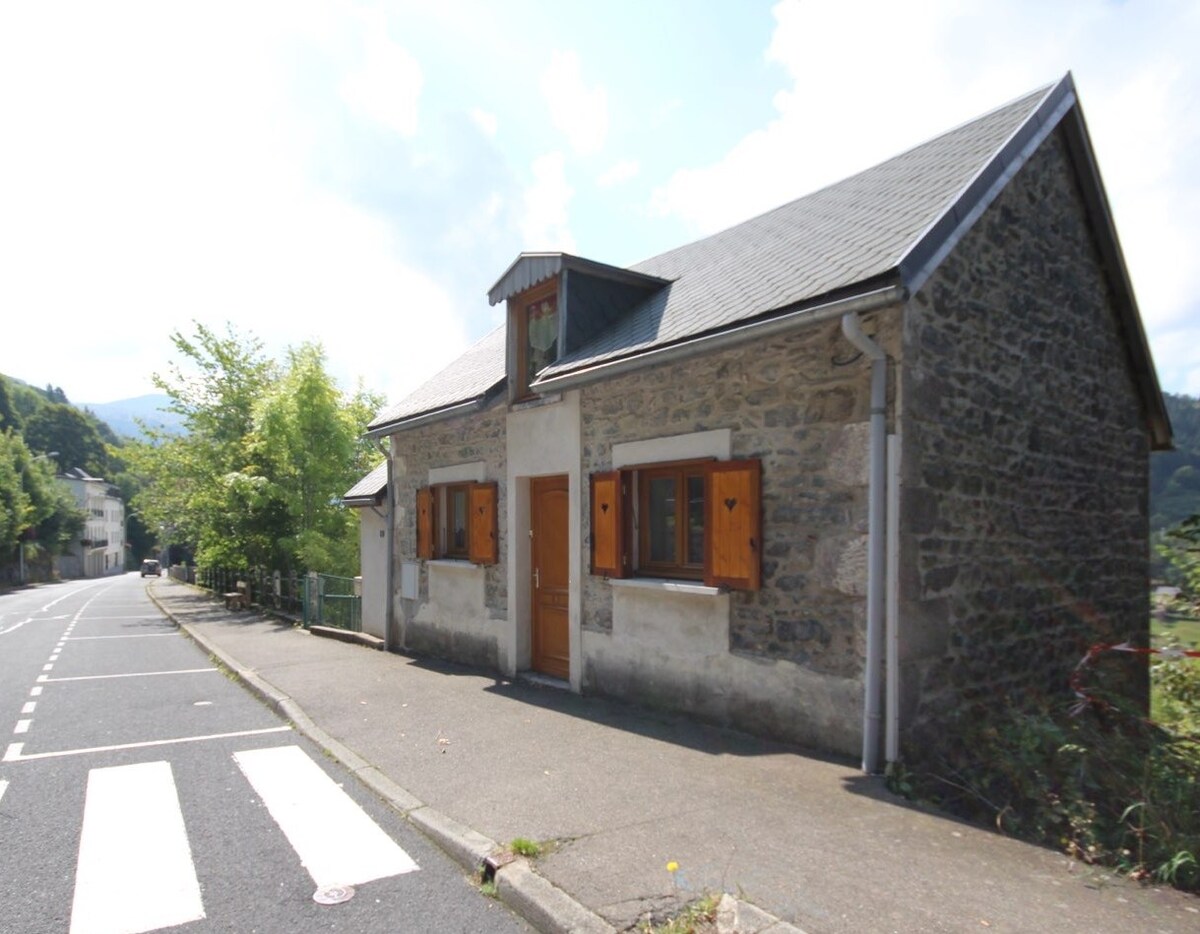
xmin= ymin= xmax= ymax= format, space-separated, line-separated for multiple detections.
xmin=127 ymin=324 xmax=382 ymax=575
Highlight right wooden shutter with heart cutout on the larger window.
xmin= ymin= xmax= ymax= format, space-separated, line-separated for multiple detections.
xmin=704 ymin=460 xmax=762 ymax=591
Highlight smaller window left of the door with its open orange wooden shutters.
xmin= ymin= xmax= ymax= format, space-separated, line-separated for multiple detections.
xmin=416 ymin=483 xmax=499 ymax=564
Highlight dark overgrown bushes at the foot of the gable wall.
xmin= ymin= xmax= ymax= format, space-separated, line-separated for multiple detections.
xmin=889 ymin=658 xmax=1200 ymax=891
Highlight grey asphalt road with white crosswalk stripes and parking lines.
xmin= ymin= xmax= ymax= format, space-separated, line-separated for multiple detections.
xmin=0 ymin=574 xmax=529 ymax=934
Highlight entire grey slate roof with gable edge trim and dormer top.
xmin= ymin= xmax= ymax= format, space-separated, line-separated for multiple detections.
xmin=371 ymin=74 xmax=1171 ymax=447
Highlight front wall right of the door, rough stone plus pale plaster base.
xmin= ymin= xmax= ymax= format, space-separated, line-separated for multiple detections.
xmin=581 ymin=312 xmax=900 ymax=753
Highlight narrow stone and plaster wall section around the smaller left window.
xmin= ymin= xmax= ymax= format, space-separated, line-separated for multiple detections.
xmin=392 ymin=405 xmax=508 ymax=667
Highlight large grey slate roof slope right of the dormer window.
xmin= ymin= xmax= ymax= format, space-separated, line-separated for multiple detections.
xmin=545 ymin=81 xmax=1050 ymax=376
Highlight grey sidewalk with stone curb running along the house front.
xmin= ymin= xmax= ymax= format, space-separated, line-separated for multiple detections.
xmin=148 ymin=579 xmax=1200 ymax=934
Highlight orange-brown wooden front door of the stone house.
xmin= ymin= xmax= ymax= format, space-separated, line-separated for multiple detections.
xmin=529 ymin=477 xmax=571 ymax=681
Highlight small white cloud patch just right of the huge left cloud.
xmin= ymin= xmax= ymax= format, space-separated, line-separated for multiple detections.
xmin=341 ymin=17 xmax=422 ymax=137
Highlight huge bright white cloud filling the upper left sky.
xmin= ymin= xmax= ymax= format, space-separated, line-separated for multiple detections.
xmin=0 ymin=5 xmax=460 ymax=402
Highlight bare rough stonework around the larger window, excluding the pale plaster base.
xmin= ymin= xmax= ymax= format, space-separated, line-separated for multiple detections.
xmin=582 ymin=315 xmax=899 ymax=677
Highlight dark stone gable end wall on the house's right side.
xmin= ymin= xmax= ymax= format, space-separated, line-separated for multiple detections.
xmin=901 ymin=127 xmax=1148 ymax=729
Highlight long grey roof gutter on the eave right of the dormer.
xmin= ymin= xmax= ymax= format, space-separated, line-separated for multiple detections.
xmin=533 ymin=279 xmax=908 ymax=391
